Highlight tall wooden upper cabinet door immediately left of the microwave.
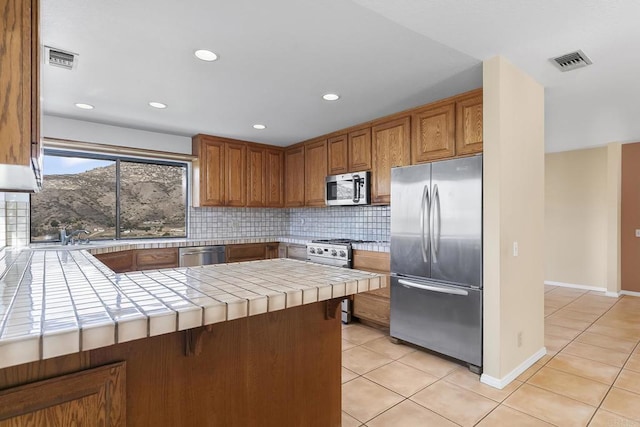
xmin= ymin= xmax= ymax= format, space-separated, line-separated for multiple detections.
xmin=304 ymin=139 xmax=327 ymax=206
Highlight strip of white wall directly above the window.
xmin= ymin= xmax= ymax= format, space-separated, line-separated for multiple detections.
xmin=42 ymin=115 xmax=191 ymax=154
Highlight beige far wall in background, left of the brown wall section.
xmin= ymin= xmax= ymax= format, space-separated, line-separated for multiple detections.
xmin=544 ymin=147 xmax=608 ymax=288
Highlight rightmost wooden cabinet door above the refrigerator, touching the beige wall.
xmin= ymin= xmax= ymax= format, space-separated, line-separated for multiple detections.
xmin=456 ymin=90 xmax=482 ymax=155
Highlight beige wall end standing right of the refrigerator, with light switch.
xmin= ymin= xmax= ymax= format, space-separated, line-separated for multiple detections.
xmin=483 ymin=57 xmax=544 ymax=380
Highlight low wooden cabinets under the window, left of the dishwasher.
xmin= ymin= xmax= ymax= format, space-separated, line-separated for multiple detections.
xmin=95 ymin=248 xmax=180 ymax=273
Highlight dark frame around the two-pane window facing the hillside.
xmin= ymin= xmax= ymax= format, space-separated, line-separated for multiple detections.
xmin=29 ymin=147 xmax=192 ymax=244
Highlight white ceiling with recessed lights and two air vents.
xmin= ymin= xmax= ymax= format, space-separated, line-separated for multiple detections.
xmin=42 ymin=0 xmax=640 ymax=151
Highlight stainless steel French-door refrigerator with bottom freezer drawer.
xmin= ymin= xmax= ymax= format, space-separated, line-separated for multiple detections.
xmin=390 ymin=155 xmax=482 ymax=372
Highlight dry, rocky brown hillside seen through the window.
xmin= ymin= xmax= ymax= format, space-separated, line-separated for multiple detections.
xmin=31 ymin=161 xmax=185 ymax=240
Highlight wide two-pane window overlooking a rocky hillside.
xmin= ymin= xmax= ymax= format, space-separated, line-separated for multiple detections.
xmin=31 ymin=150 xmax=187 ymax=242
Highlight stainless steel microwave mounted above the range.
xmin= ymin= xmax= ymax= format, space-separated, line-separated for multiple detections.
xmin=324 ymin=171 xmax=371 ymax=206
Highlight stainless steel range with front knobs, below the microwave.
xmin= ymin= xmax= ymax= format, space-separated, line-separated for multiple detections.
xmin=307 ymin=239 xmax=366 ymax=323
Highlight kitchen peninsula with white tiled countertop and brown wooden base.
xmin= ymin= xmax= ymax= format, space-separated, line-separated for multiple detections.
xmin=0 ymin=249 xmax=381 ymax=426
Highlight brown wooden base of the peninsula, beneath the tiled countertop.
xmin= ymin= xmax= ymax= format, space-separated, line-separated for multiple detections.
xmin=0 ymin=301 xmax=342 ymax=427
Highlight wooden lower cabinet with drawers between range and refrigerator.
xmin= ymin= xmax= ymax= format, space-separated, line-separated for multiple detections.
xmin=353 ymin=250 xmax=391 ymax=328
